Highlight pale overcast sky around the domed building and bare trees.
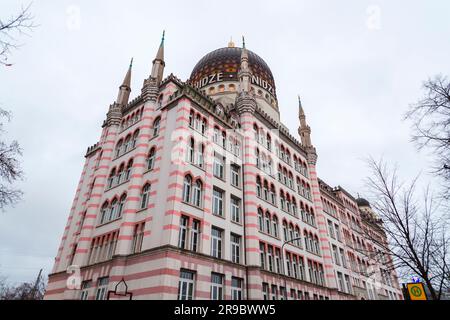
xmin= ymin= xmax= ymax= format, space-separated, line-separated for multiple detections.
xmin=0 ymin=0 xmax=450 ymax=282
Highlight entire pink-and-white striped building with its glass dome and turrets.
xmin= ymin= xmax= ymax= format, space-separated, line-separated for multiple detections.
xmin=45 ymin=38 xmax=402 ymax=300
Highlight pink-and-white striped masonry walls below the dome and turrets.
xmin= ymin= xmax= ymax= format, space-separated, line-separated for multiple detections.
xmin=45 ymin=43 xmax=401 ymax=300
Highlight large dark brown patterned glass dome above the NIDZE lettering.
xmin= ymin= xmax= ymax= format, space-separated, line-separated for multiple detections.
xmin=190 ymin=46 xmax=276 ymax=98
